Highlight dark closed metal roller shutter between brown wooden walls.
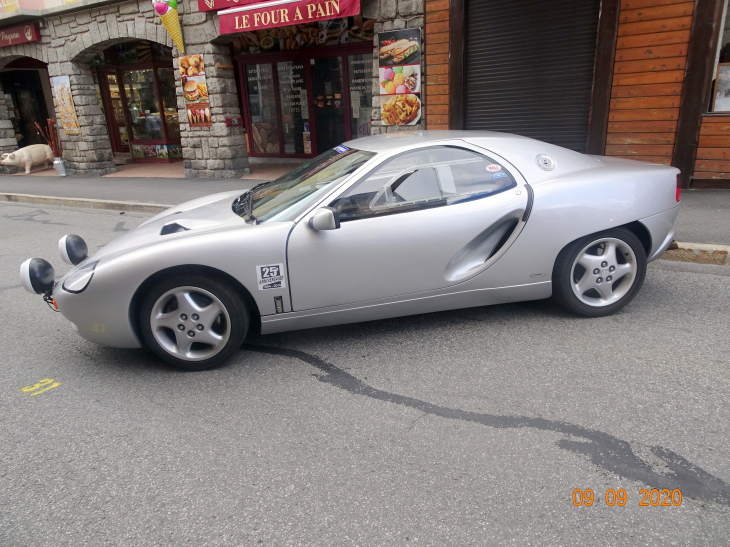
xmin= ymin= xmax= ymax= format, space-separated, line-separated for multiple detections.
xmin=464 ymin=0 xmax=601 ymax=152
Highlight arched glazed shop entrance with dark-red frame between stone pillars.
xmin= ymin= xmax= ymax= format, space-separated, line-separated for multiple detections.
xmin=91 ymin=41 xmax=182 ymax=163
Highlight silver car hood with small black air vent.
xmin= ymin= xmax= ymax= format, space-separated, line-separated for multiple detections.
xmin=89 ymin=190 xmax=247 ymax=260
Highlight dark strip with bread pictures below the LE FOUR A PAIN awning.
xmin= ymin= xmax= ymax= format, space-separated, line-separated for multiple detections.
xmin=232 ymin=15 xmax=375 ymax=54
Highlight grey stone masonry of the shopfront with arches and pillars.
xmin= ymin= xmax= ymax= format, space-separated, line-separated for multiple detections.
xmin=0 ymin=0 xmax=425 ymax=178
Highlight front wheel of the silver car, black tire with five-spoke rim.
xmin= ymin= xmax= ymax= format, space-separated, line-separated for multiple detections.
xmin=139 ymin=275 xmax=250 ymax=370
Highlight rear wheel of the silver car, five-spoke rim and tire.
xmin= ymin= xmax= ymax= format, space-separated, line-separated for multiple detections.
xmin=553 ymin=228 xmax=646 ymax=317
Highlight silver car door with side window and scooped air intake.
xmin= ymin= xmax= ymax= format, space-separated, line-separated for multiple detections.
xmin=287 ymin=145 xmax=528 ymax=311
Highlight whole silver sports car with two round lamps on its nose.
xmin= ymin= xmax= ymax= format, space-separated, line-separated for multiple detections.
xmin=20 ymin=131 xmax=679 ymax=370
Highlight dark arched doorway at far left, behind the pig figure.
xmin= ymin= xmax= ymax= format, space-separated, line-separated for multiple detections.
xmin=0 ymin=57 xmax=53 ymax=148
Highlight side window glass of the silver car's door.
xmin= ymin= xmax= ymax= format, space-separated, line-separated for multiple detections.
xmin=330 ymin=146 xmax=517 ymax=221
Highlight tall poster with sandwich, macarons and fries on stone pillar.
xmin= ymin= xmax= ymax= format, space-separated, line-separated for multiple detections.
xmin=378 ymin=29 xmax=422 ymax=125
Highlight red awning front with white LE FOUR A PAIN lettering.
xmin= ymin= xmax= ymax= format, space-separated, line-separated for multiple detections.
xmin=218 ymin=0 xmax=360 ymax=34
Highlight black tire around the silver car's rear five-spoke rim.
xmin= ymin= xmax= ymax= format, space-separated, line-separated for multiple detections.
xmin=553 ymin=228 xmax=646 ymax=317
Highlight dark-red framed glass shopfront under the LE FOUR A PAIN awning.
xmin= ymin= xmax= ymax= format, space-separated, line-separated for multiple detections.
xmin=237 ymin=43 xmax=374 ymax=158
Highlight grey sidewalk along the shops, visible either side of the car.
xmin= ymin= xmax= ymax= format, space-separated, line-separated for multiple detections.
xmin=0 ymin=173 xmax=730 ymax=245
